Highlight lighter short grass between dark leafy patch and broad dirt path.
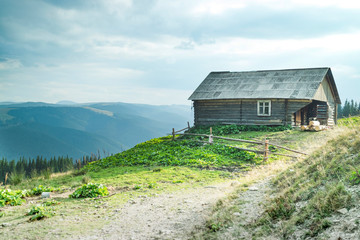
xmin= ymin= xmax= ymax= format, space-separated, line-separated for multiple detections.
xmin=0 ymin=166 xmax=238 ymax=239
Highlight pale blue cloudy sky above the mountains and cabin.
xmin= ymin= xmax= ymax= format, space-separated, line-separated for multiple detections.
xmin=0 ymin=0 xmax=360 ymax=104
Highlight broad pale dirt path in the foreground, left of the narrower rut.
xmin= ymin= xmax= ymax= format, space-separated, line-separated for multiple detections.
xmin=75 ymin=181 xmax=238 ymax=240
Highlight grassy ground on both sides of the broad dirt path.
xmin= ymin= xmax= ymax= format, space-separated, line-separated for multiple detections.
xmin=0 ymin=122 xmax=360 ymax=239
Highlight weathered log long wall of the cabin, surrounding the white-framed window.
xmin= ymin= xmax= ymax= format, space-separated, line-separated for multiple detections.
xmin=194 ymin=99 xmax=311 ymax=125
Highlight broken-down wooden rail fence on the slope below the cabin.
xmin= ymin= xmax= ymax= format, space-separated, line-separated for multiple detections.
xmin=172 ymin=125 xmax=308 ymax=162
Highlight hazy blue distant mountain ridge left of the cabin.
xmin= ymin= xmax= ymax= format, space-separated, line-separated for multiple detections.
xmin=0 ymin=101 xmax=192 ymax=160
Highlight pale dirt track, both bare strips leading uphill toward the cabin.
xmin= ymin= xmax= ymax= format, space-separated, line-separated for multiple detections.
xmin=73 ymin=128 xmax=346 ymax=240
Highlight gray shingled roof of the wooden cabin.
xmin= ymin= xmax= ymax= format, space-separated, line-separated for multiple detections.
xmin=189 ymin=68 xmax=340 ymax=103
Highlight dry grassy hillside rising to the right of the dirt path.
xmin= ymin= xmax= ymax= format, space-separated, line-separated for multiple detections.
xmin=195 ymin=117 xmax=360 ymax=239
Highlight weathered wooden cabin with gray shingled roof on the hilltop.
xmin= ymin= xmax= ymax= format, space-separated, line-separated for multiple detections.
xmin=189 ymin=68 xmax=341 ymax=126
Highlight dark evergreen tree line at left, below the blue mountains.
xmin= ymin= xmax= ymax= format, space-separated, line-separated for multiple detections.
xmin=0 ymin=154 xmax=100 ymax=185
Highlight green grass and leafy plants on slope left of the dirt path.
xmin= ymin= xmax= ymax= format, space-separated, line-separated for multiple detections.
xmin=0 ymin=124 xmax=342 ymax=239
